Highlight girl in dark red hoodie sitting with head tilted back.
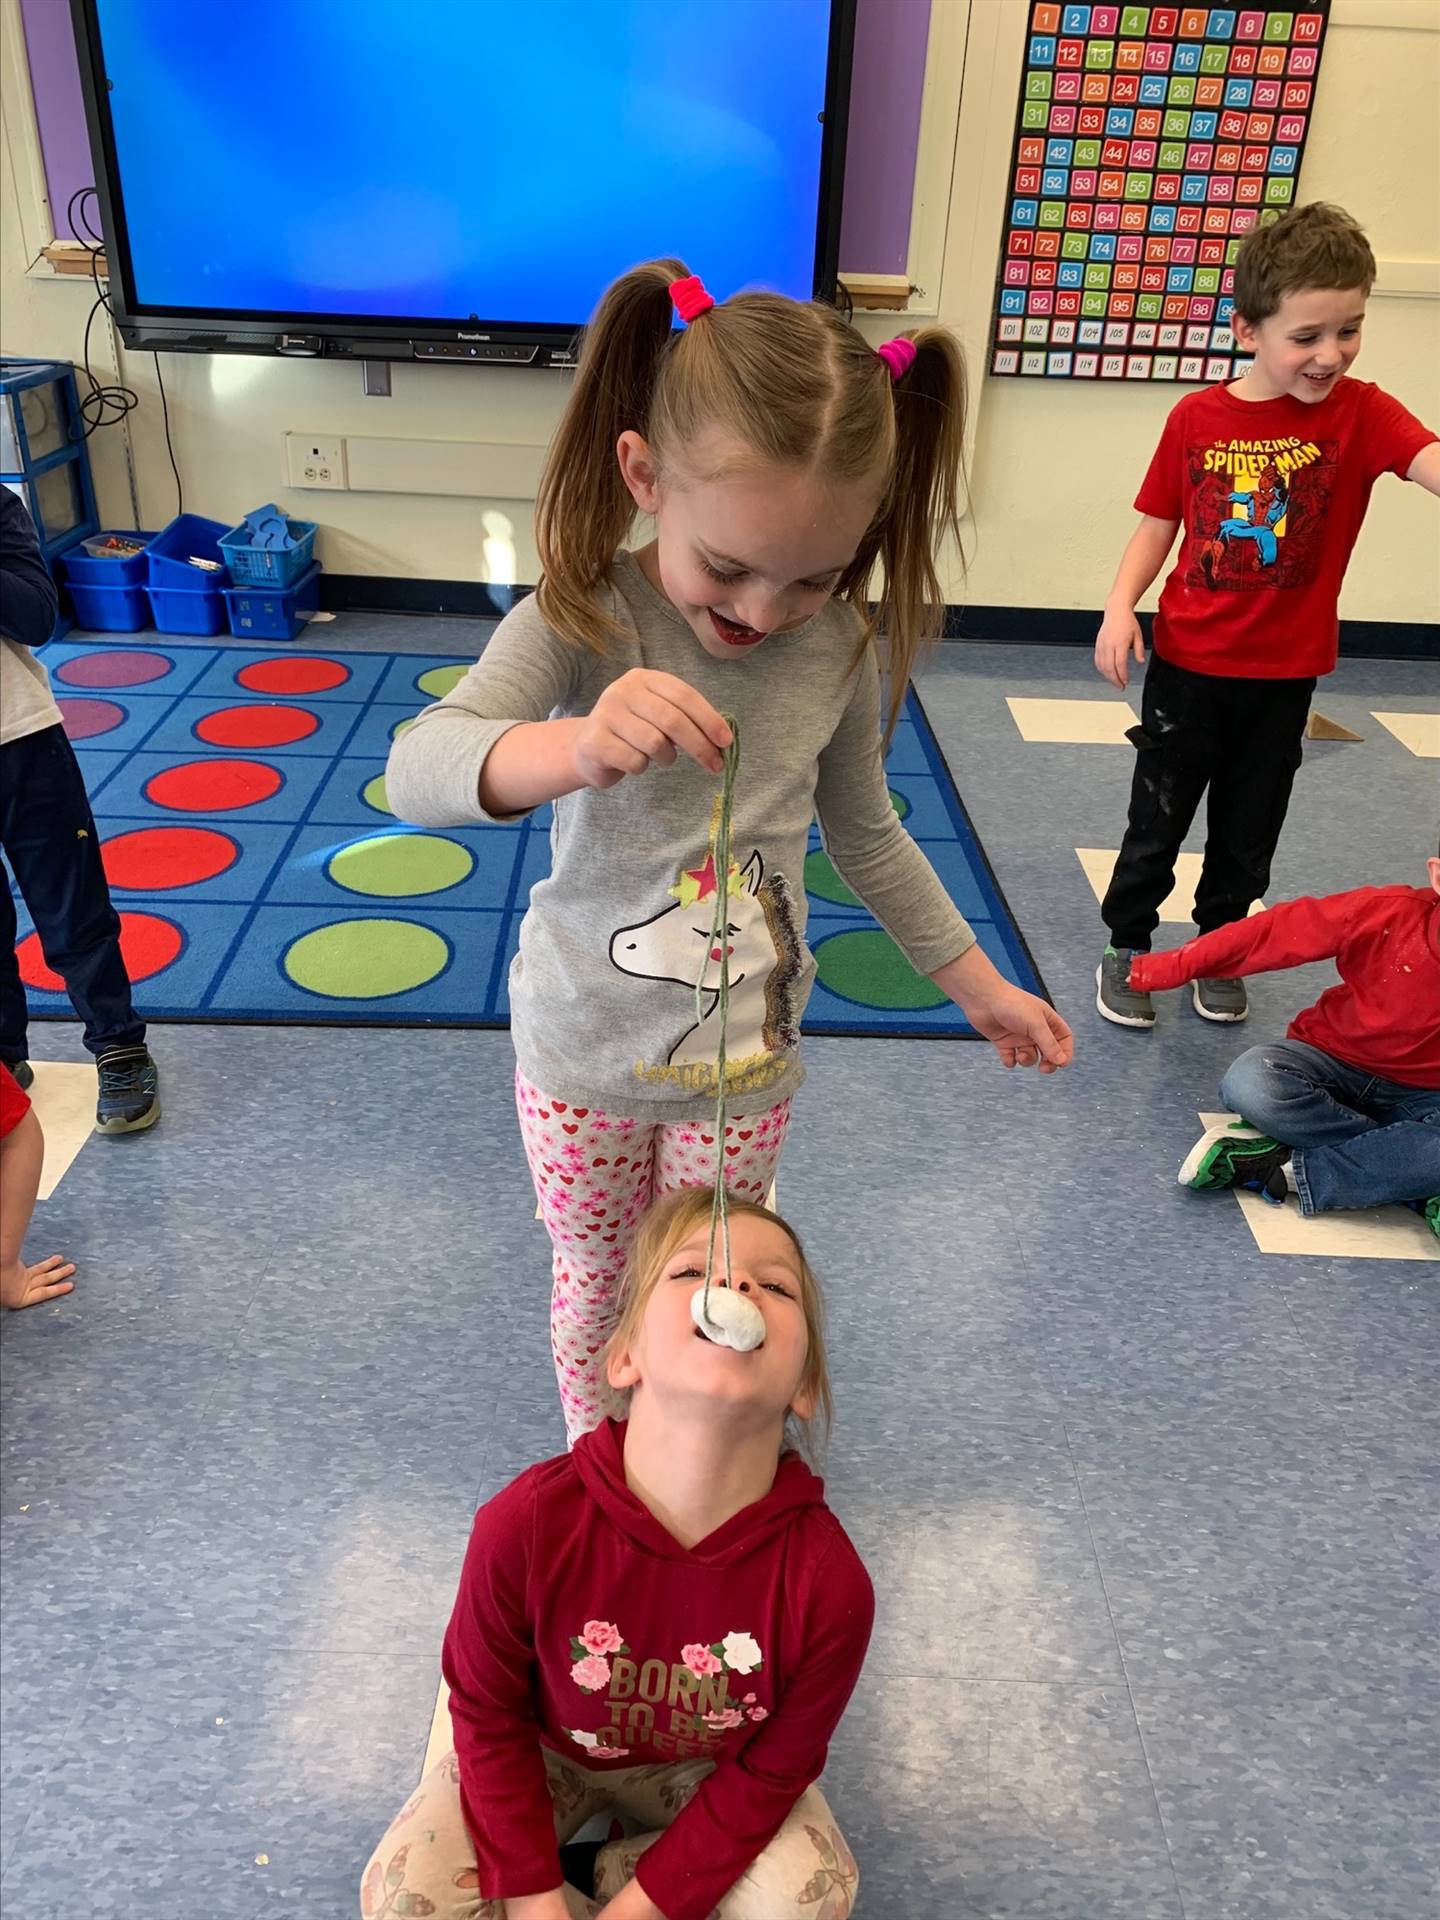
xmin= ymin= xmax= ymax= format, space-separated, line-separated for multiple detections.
xmin=361 ymin=1188 xmax=874 ymax=1920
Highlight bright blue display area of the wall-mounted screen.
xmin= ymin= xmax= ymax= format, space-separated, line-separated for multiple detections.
xmin=96 ymin=0 xmax=829 ymax=324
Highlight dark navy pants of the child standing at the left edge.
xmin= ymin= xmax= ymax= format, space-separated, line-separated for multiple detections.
xmin=0 ymin=726 xmax=146 ymax=1060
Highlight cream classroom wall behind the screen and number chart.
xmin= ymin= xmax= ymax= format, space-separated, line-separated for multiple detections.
xmin=0 ymin=0 xmax=1440 ymax=620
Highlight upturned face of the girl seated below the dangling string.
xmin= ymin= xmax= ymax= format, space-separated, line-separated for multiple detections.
xmin=611 ymin=1213 xmax=814 ymax=1419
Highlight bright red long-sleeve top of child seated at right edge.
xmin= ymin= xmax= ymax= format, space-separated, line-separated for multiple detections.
xmin=1131 ymin=887 xmax=1440 ymax=1091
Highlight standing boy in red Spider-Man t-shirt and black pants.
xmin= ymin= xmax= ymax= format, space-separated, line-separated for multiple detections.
xmin=1094 ymin=202 xmax=1440 ymax=1027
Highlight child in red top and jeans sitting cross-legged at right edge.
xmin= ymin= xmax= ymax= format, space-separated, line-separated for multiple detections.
xmin=1129 ymin=858 xmax=1440 ymax=1236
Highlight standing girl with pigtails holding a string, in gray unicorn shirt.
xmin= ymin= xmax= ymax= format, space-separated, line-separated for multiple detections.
xmin=386 ymin=261 xmax=1071 ymax=1440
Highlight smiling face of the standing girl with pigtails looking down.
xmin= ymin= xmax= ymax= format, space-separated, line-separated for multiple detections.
xmin=616 ymin=432 xmax=881 ymax=660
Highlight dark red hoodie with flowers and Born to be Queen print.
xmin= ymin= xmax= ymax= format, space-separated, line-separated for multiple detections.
xmin=444 ymin=1421 xmax=876 ymax=1920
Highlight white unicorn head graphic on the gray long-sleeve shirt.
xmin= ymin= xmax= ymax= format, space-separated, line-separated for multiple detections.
xmin=611 ymin=847 xmax=801 ymax=1087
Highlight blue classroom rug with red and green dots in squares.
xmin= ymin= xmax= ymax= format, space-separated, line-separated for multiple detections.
xmin=17 ymin=636 xmax=1044 ymax=1039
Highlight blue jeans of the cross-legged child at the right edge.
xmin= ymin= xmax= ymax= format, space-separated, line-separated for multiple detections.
xmin=1219 ymin=1041 xmax=1440 ymax=1213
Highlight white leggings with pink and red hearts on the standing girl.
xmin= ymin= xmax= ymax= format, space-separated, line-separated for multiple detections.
xmin=515 ymin=1071 xmax=791 ymax=1440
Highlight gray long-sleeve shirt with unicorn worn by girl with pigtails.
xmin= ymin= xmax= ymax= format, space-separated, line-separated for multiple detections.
xmin=386 ymin=555 xmax=975 ymax=1125
